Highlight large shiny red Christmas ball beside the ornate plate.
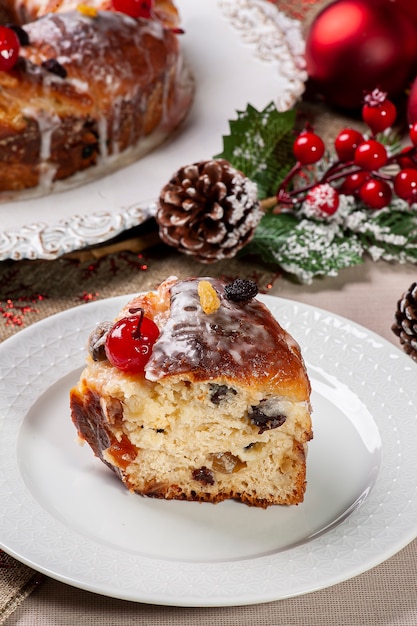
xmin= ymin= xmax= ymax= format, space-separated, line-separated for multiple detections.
xmin=305 ymin=0 xmax=417 ymax=110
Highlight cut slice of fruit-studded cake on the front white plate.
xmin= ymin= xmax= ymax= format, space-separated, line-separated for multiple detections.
xmin=70 ymin=278 xmax=312 ymax=507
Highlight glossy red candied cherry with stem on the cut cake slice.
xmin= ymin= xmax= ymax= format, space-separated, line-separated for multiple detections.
xmin=105 ymin=309 xmax=159 ymax=374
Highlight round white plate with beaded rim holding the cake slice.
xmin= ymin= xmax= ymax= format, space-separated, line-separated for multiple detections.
xmin=0 ymin=296 xmax=417 ymax=606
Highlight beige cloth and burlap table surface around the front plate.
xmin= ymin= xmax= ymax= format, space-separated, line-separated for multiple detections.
xmin=0 ymin=0 xmax=417 ymax=626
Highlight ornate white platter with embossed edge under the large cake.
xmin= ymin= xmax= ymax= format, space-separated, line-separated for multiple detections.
xmin=0 ymin=0 xmax=306 ymax=260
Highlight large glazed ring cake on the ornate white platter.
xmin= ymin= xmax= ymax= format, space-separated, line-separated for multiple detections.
xmin=0 ymin=0 xmax=193 ymax=193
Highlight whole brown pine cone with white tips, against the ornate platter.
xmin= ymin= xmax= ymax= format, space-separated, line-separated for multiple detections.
xmin=156 ymin=159 xmax=262 ymax=263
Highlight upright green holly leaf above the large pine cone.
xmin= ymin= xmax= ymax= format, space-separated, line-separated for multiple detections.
xmin=214 ymin=103 xmax=295 ymax=200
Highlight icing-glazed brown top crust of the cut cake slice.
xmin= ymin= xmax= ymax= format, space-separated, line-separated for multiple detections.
xmin=145 ymin=278 xmax=299 ymax=381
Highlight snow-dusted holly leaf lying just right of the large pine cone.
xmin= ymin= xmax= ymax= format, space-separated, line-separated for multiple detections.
xmin=244 ymin=213 xmax=364 ymax=283
